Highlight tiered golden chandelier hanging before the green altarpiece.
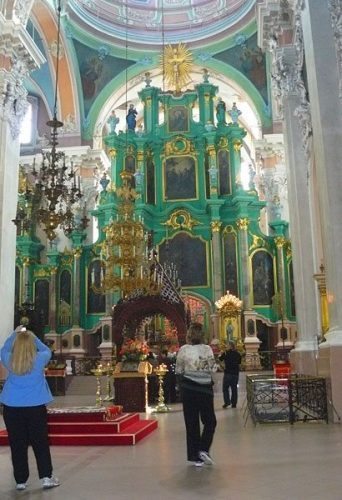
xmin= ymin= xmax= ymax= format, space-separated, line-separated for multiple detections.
xmin=92 ymin=170 xmax=162 ymax=298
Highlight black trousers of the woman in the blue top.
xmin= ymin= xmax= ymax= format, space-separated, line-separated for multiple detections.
xmin=3 ymin=405 xmax=52 ymax=483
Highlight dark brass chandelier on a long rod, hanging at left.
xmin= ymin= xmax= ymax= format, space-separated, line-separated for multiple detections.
xmin=13 ymin=0 xmax=89 ymax=241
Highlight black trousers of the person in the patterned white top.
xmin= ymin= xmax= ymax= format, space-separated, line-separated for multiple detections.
xmin=182 ymin=389 xmax=216 ymax=461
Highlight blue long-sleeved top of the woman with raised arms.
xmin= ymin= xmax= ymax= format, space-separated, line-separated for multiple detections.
xmin=0 ymin=332 xmax=53 ymax=407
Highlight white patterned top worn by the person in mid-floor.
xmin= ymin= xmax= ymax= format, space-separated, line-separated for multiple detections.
xmin=176 ymin=344 xmax=217 ymax=385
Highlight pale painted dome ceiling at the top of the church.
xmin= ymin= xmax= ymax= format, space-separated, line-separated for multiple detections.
xmin=66 ymin=0 xmax=255 ymax=48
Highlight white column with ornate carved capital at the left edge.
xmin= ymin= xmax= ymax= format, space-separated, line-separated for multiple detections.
xmin=0 ymin=12 xmax=44 ymax=352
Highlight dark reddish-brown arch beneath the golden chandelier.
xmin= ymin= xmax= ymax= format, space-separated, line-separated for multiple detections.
xmin=112 ymin=295 xmax=187 ymax=351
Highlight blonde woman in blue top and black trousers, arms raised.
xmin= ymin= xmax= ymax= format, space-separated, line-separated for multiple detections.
xmin=0 ymin=326 xmax=59 ymax=490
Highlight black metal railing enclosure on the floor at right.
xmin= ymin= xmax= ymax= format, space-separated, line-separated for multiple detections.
xmin=245 ymin=374 xmax=328 ymax=424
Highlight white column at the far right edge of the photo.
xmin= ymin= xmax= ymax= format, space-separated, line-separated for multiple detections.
xmin=302 ymin=0 xmax=342 ymax=345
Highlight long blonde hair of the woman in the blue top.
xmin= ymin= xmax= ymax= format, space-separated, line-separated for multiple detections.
xmin=11 ymin=330 xmax=37 ymax=375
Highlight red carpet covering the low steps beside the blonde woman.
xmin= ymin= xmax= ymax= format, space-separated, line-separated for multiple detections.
xmin=0 ymin=407 xmax=158 ymax=446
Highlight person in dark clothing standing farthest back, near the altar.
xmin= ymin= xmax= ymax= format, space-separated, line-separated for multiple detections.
xmin=219 ymin=340 xmax=241 ymax=408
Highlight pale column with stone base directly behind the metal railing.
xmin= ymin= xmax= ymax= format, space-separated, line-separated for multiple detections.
xmin=277 ymin=46 xmax=320 ymax=374
